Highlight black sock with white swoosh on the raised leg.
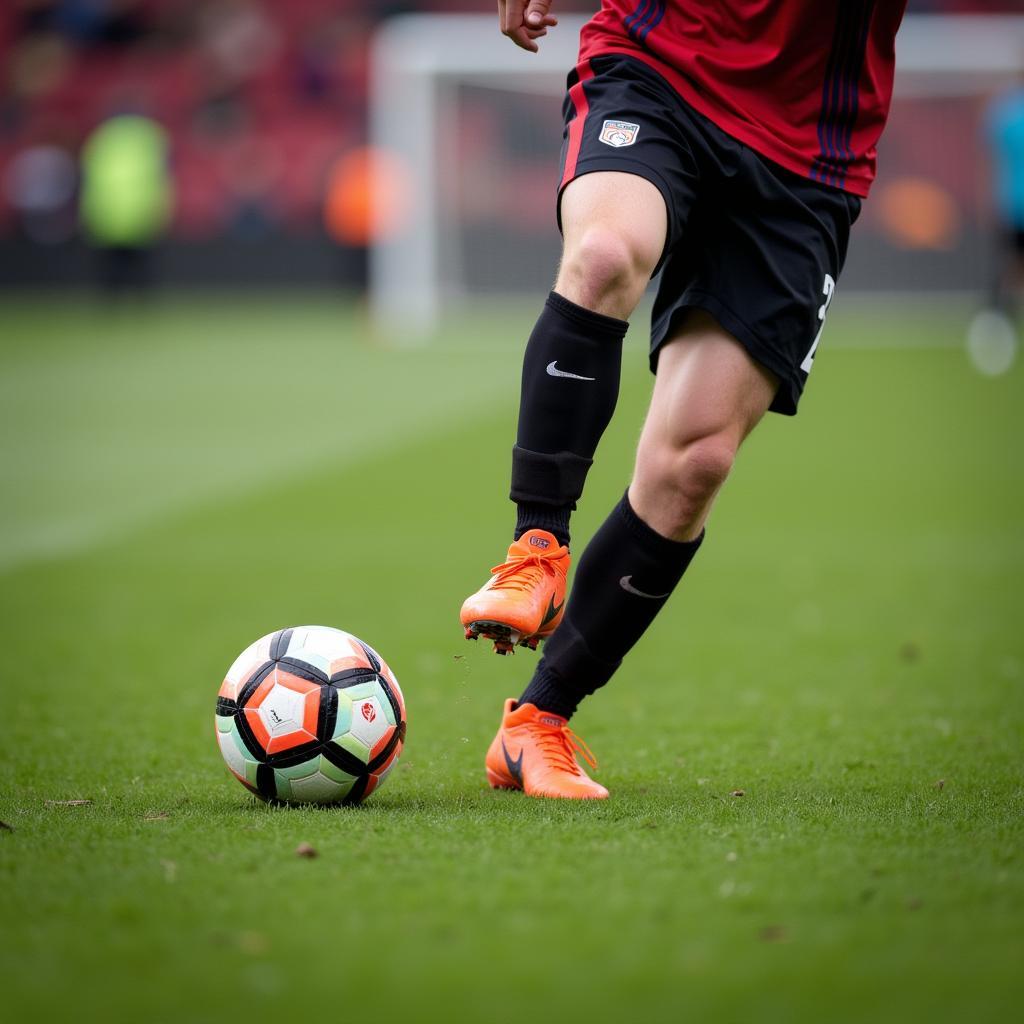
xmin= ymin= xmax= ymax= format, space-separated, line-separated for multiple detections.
xmin=510 ymin=292 xmax=629 ymax=544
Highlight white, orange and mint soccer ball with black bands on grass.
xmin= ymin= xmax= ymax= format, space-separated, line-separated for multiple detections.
xmin=216 ymin=626 xmax=406 ymax=804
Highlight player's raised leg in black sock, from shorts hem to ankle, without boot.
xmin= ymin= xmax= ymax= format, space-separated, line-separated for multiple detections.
xmin=511 ymin=171 xmax=668 ymax=545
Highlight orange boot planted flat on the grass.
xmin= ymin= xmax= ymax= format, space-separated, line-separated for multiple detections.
xmin=484 ymin=699 xmax=608 ymax=800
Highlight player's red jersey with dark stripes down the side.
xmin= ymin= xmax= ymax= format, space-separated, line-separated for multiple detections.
xmin=580 ymin=0 xmax=906 ymax=196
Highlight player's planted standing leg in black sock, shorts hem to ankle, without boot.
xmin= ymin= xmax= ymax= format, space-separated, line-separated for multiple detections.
xmin=520 ymin=310 xmax=778 ymax=719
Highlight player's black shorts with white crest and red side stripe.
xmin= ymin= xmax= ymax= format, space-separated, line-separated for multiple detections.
xmin=558 ymin=55 xmax=860 ymax=416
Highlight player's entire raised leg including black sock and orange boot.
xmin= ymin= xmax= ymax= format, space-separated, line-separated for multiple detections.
xmin=461 ymin=172 xmax=668 ymax=654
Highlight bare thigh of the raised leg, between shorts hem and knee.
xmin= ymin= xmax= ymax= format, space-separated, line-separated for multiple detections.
xmin=560 ymin=171 xmax=669 ymax=278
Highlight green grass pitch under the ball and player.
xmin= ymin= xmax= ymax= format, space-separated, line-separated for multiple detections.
xmin=0 ymin=297 xmax=1024 ymax=1024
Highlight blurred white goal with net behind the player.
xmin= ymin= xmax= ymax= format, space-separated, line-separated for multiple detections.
xmin=370 ymin=14 xmax=1024 ymax=338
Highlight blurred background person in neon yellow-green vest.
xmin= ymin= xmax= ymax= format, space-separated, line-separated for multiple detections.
xmin=80 ymin=114 xmax=173 ymax=291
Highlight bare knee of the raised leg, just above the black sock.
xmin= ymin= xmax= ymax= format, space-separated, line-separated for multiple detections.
xmin=559 ymin=224 xmax=657 ymax=318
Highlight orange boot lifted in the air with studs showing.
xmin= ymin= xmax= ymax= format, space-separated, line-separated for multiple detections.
xmin=461 ymin=529 xmax=569 ymax=654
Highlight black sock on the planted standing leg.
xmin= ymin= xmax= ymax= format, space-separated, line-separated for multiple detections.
xmin=519 ymin=495 xmax=703 ymax=718
